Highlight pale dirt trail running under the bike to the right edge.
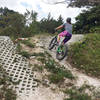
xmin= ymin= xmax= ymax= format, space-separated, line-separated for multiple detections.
xmin=41 ymin=35 xmax=100 ymax=88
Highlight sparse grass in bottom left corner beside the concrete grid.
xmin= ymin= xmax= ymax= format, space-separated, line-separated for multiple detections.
xmin=0 ymin=66 xmax=18 ymax=100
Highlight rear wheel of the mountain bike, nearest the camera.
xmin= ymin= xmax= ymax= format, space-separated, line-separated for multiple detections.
xmin=56 ymin=45 xmax=68 ymax=60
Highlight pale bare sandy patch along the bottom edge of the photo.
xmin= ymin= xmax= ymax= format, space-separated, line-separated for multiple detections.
xmin=18 ymin=86 xmax=64 ymax=100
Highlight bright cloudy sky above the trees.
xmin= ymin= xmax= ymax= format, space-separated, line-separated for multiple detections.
xmin=0 ymin=0 xmax=82 ymax=23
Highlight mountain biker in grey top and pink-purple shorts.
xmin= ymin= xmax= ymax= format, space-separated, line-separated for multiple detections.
xmin=55 ymin=17 xmax=72 ymax=45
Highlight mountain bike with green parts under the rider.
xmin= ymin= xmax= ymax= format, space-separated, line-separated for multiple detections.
xmin=48 ymin=36 xmax=68 ymax=60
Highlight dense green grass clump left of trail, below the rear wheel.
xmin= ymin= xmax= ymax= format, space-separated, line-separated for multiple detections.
xmin=45 ymin=59 xmax=74 ymax=84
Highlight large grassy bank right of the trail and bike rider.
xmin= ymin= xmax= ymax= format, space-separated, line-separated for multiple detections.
xmin=68 ymin=34 xmax=100 ymax=77
